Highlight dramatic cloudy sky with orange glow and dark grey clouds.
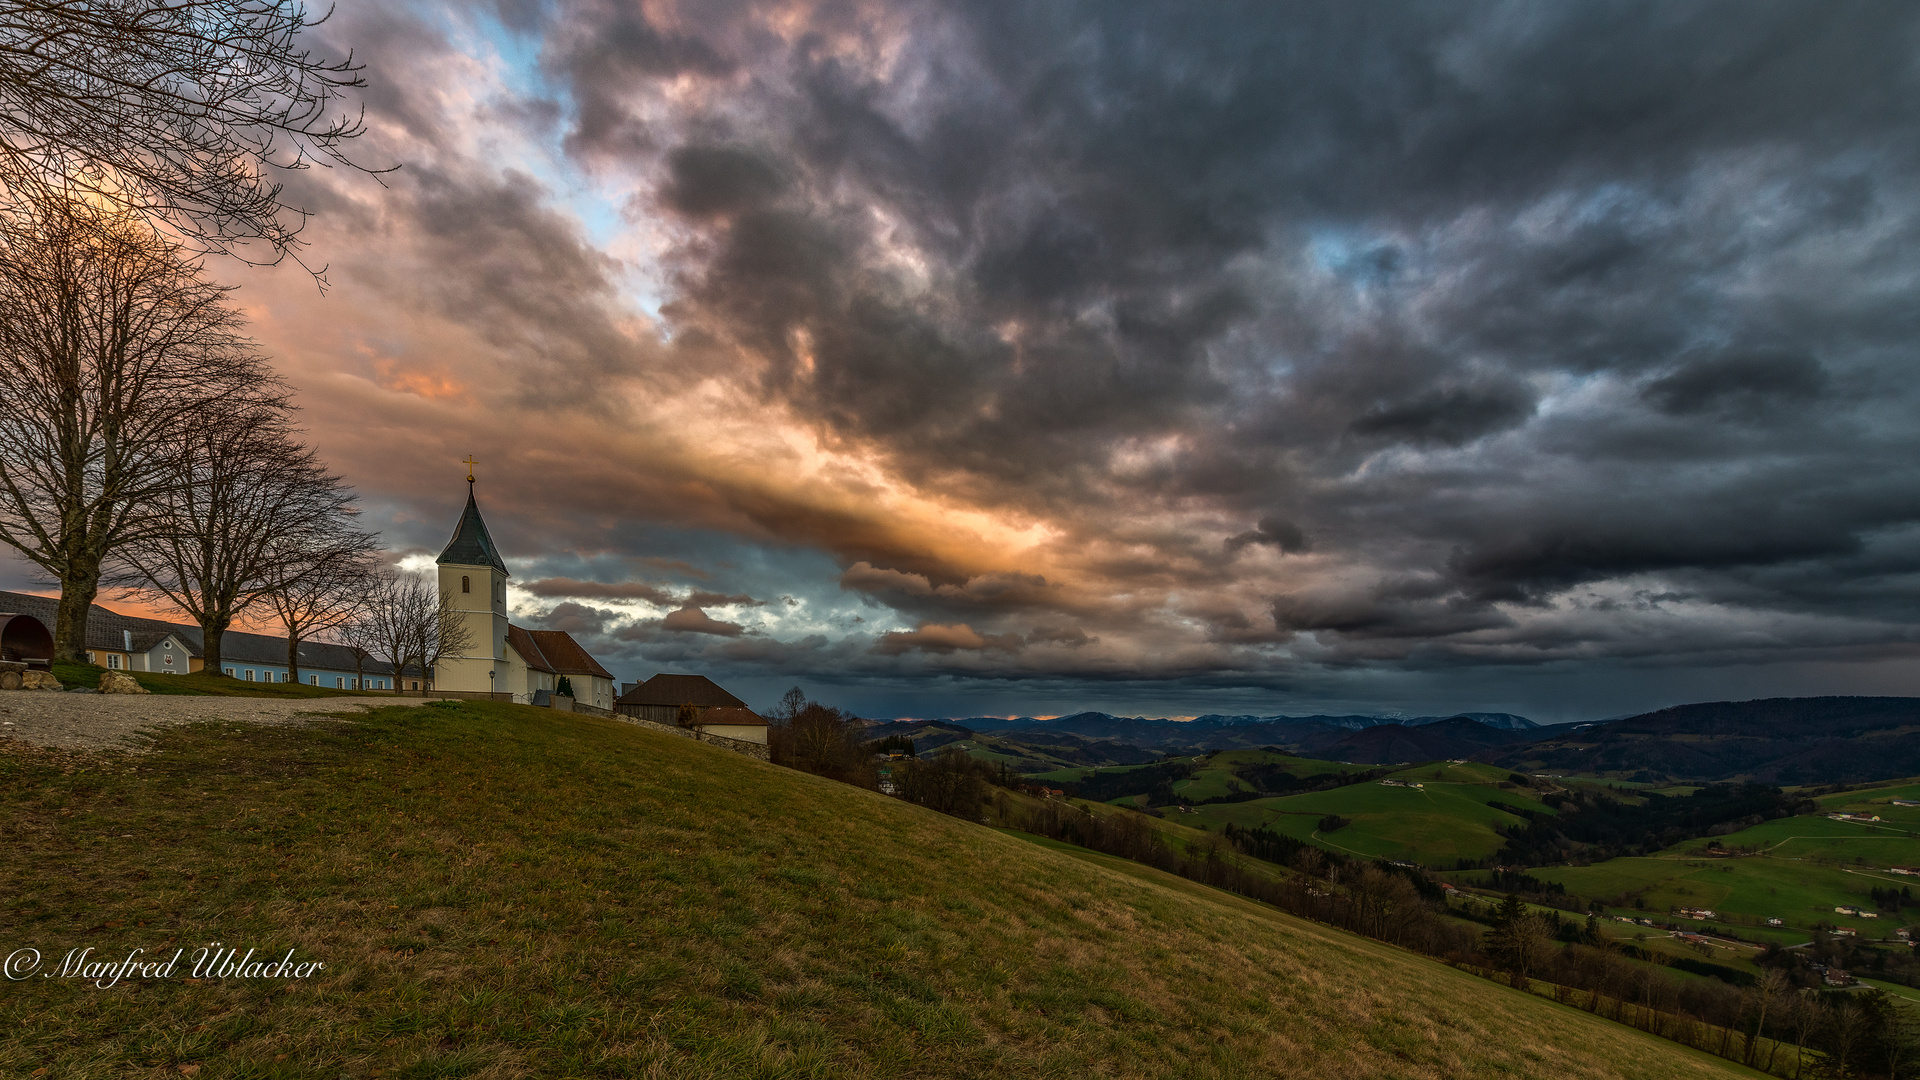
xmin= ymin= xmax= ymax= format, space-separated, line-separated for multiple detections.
xmin=8 ymin=0 xmax=1920 ymax=721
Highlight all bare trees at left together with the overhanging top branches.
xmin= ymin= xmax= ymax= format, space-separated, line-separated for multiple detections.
xmin=0 ymin=0 xmax=449 ymax=678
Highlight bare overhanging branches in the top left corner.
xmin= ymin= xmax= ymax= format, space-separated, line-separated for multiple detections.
xmin=0 ymin=0 xmax=382 ymax=261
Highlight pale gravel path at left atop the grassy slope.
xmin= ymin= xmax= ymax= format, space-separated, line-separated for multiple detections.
xmin=0 ymin=690 xmax=405 ymax=751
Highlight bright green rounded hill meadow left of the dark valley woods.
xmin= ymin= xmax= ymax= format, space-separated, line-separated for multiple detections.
xmin=1194 ymin=767 xmax=1553 ymax=869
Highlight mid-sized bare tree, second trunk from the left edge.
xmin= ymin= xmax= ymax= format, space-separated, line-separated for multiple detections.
xmin=121 ymin=409 xmax=353 ymax=673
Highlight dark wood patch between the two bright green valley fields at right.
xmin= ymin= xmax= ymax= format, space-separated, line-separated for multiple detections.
xmin=1494 ymin=784 xmax=1812 ymax=867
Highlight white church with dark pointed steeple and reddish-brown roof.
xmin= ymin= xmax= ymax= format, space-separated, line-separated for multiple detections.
xmin=434 ymin=473 xmax=614 ymax=713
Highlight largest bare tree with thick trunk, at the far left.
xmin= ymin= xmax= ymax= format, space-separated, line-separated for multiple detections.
xmin=0 ymin=194 xmax=280 ymax=661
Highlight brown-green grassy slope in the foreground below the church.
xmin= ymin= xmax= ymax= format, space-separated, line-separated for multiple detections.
xmin=0 ymin=691 xmax=1745 ymax=1080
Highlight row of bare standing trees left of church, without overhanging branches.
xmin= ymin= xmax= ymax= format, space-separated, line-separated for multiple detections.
xmin=0 ymin=192 xmax=468 ymax=678
